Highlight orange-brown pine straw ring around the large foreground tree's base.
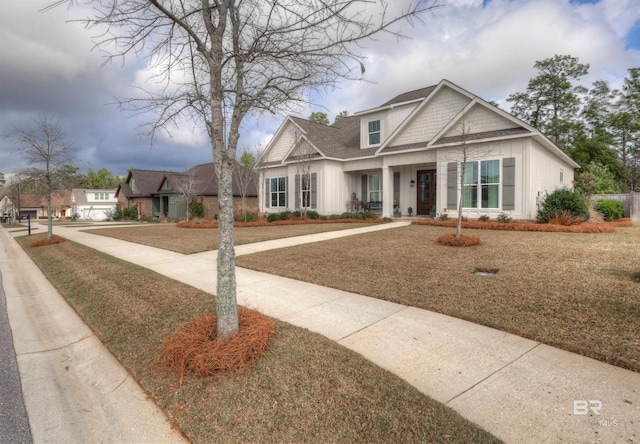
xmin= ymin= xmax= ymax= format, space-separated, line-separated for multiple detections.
xmin=158 ymin=307 xmax=275 ymax=383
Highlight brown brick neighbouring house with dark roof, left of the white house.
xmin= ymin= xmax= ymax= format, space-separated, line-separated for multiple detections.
xmin=116 ymin=163 xmax=258 ymax=219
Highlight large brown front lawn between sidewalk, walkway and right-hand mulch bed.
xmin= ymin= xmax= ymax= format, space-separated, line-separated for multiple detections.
xmin=236 ymin=224 xmax=640 ymax=371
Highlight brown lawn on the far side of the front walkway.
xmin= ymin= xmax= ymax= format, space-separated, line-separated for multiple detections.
xmin=87 ymin=222 xmax=371 ymax=254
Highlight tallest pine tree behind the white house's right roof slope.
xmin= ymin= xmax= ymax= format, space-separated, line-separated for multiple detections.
xmin=507 ymin=55 xmax=589 ymax=149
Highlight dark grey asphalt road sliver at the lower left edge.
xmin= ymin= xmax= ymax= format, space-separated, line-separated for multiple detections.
xmin=0 ymin=273 xmax=33 ymax=444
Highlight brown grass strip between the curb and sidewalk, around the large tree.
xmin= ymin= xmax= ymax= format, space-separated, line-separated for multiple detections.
xmin=17 ymin=234 xmax=498 ymax=443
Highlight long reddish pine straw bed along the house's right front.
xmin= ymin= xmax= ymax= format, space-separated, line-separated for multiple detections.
xmin=412 ymin=218 xmax=632 ymax=233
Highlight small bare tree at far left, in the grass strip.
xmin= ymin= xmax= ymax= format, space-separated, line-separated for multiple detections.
xmin=10 ymin=114 xmax=74 ymax=239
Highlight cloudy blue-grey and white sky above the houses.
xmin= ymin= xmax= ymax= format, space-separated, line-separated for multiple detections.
xmin=0 ymin=0 xmax=640 ymax=179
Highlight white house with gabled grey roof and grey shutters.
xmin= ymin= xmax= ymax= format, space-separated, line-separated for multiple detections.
xmin=257 ymin=80 xmax=578 ymax=219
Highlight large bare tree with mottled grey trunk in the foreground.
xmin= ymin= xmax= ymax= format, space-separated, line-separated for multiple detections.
xmin=52 ymin=0 xmax=435 ymax=337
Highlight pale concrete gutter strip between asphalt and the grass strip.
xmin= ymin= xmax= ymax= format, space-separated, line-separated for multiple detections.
xmin=0 ymin=229 xmax=186 ymax=443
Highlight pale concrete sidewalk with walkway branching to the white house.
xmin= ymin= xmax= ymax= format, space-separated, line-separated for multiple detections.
xmin=5 ymin=222 xmax=640 ymax=443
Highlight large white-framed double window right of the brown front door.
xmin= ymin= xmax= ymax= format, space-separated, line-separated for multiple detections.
xmin=462 ymin=159 xmax=500 ymax=208
